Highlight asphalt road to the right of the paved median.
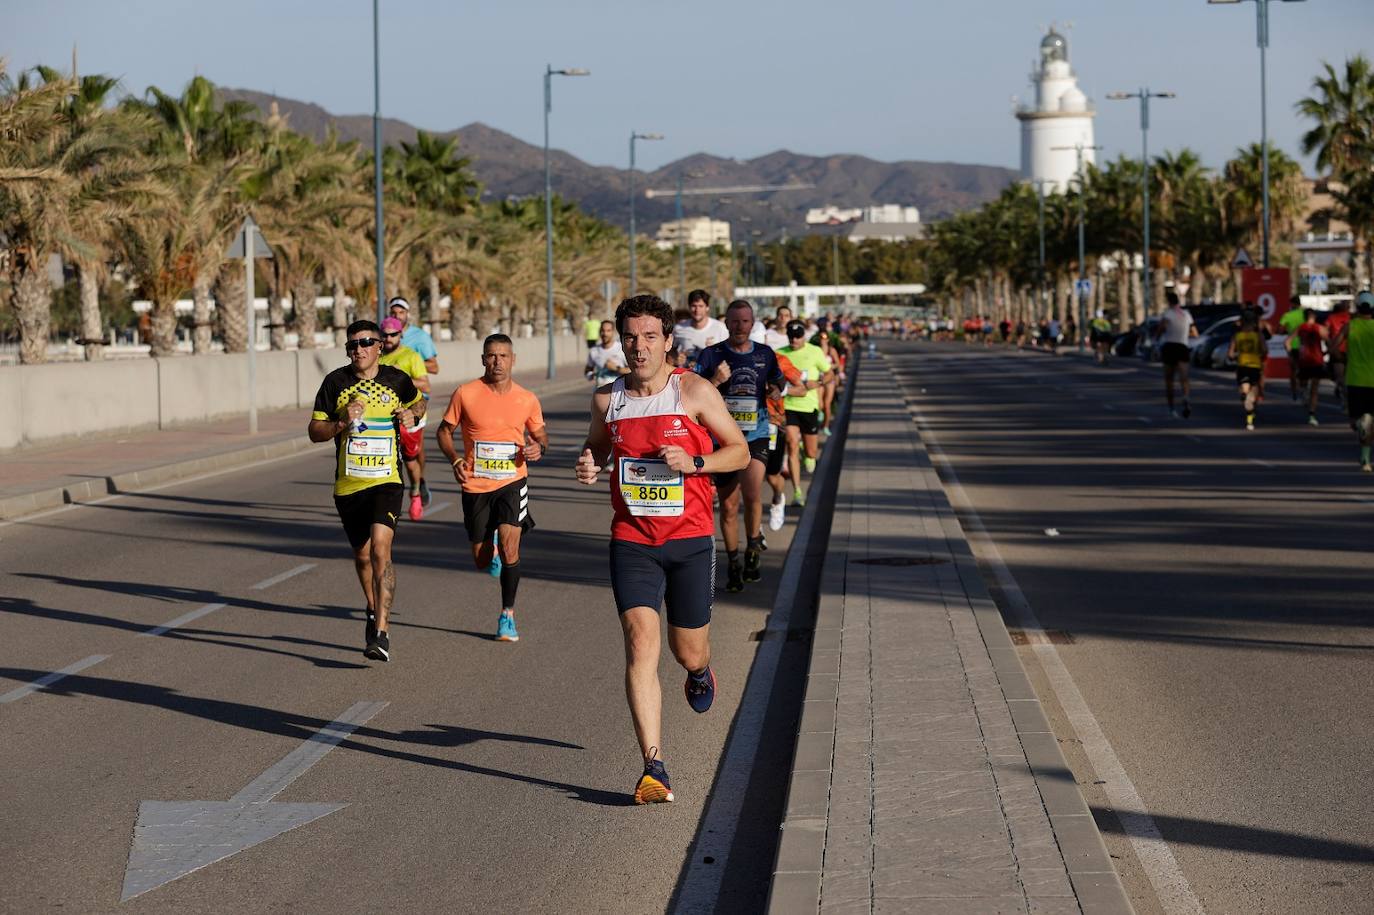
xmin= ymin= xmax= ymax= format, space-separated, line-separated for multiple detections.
xmin=882 ymin=342 xmax=1374 ymax=912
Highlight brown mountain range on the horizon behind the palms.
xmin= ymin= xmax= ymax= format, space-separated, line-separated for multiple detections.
xmin=220 ymin=89 xmax=1017 ymax=238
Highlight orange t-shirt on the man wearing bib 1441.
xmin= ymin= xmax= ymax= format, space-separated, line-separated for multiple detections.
xmin=444 ymin=378 xmax=544 ymax=492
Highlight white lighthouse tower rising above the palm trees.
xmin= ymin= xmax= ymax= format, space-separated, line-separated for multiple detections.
xmin=1017 ymin=29 xmax=1096 ymax=192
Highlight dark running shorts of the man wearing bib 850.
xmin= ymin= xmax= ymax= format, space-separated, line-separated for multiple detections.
xmin=610 ymin=537 xmax=716 ymax=629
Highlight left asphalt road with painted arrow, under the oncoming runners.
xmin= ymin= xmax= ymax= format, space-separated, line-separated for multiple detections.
xmin=0 ymin=376 xmax=823 ymax=912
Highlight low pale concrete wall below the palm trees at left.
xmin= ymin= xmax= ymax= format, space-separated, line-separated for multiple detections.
xmin=0 ymin=335 xmax=587 ymax=451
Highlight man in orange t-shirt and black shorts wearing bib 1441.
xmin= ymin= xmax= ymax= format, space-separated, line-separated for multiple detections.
xmin=436 ymin=334 xmax=548 ymax=642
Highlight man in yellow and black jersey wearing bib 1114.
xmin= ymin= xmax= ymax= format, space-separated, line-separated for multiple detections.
xmin=308 ymin=320 xmax=426 ymax=661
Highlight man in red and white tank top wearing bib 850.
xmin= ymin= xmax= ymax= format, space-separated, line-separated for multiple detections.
xmin=577 ymin=295 xmax=749 ymax=804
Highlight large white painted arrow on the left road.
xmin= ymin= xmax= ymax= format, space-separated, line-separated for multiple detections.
xmin=120 ymin=702 xmax=386 ymax=903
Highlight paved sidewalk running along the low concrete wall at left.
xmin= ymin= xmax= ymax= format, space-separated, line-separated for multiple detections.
xmin=0 ymin=365 xmax=591 ymax=521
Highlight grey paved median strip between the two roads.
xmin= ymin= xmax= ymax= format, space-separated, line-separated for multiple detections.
xmin=769 ymin=357 xmax=1131 ymax=914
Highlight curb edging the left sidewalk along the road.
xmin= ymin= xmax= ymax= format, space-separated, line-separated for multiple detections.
xmin=0 ymin=368 xmax=591 ymax=521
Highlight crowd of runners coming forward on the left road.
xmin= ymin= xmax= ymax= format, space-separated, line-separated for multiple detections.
xmin=309 ymin=290 xmax=857 ymax=804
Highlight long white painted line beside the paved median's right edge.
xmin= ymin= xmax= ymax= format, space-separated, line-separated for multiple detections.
xmin=912 ymin=398 xmax=1202 ymax=915
